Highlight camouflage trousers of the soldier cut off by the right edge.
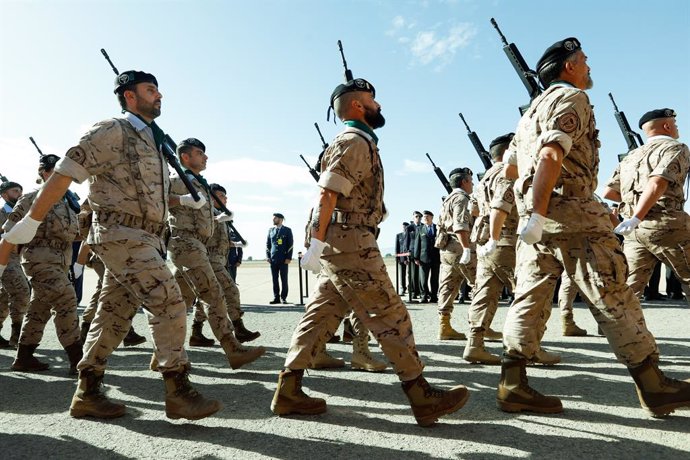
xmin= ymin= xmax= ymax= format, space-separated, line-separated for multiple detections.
xmin=623 ymin=227 xmax=690 ymax=301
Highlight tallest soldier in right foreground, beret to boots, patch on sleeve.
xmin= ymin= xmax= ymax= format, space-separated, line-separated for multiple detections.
xmin=497 ymin=37 xmax=690 ymax=416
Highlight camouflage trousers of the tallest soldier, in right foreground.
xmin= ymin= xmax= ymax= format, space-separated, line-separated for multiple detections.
xmin=503 ymin=233 xmax=658 ymax=366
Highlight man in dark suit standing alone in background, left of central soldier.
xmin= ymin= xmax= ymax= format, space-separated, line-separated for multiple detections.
xmin=266 ymin=212 xmax=293 ymax=304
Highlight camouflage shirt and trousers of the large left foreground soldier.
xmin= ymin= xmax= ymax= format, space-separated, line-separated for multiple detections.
xmin=55 ymin=113 xmax=188 ymax=372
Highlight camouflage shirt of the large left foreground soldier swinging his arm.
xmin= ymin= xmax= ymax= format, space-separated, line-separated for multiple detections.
xmin=55 ymin=113 xmax=170 ymax=245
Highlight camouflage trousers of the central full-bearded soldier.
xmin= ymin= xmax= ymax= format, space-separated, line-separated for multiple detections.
xmin=285 ymin=248 xmax=424 ymax=381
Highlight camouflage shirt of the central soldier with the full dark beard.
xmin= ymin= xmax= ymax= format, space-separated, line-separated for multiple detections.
xmin=319 ymin=127 xmax=385 ymax=255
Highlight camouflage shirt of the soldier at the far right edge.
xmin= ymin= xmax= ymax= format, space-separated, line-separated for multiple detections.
xmin=606 ymin=136 xmax=690 ymax=230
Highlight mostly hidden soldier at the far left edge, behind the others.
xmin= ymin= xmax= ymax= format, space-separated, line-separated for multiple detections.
xmin=0 ymin=182 xmax=31 ymax=348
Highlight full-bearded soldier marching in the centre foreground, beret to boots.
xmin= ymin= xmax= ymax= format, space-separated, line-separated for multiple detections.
xmin=271 ymin=78 xmax=469 ymax=426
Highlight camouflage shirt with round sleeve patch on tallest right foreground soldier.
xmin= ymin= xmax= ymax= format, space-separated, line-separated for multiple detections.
xmin=510 ymin=83 xmax=611 ymax=234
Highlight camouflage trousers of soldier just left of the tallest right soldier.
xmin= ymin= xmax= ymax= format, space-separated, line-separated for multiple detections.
xmin=467 ymin=246 xmax=515 ymax=332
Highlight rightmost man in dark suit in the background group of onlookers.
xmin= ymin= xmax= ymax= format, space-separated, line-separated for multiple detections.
xmin=414 ymin=211 xmax=441 ymax=303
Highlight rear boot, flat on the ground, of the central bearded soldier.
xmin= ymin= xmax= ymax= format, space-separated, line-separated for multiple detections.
xmin=271 ymin=369 xmax=326 ymax=415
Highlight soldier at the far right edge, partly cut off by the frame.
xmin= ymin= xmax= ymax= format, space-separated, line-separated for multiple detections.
xmin=604 ymin=109 xmax=690 ymax=306
